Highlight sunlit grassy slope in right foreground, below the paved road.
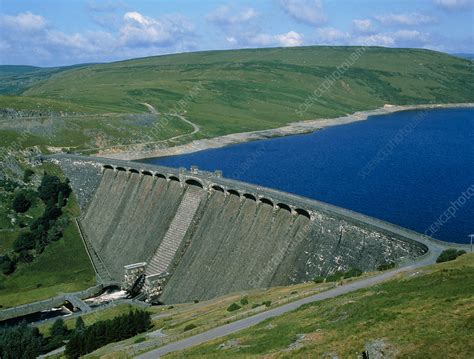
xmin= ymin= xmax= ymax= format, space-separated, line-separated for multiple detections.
xmin=166 ymin=254 xmax=474 ymax=358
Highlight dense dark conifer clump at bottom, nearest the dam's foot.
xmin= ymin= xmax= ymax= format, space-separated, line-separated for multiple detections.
xmin=65 ymin=310 xmax=151 ymax=358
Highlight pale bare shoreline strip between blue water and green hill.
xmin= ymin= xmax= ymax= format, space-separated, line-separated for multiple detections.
xmin=95 ymin=103 xmax=474 ymax=161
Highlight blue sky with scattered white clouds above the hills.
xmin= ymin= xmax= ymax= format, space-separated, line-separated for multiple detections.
xmin=0 ymin=0 xmax=474 ymax=66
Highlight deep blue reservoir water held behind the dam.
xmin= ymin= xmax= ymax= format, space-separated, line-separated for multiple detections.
xmin=139 ymin=109 xmax=474 ymax=243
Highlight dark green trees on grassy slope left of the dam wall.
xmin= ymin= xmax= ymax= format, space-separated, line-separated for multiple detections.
xmin=0 ymin=173 xmax=71 ymax=274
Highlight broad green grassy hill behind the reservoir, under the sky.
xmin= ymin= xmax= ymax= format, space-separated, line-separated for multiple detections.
xmin=0 ymin=47 xmax=474 ymax=153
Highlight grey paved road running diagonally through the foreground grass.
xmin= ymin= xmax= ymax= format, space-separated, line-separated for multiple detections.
xmin=137 ymin=253 xmax=441 ymax=359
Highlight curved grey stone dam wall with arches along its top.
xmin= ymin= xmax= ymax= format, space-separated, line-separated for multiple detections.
xmin=47 ymin=155 xmax=429 ymax=303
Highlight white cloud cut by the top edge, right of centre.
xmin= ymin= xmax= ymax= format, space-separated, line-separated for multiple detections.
xmin=280 ymin=0 xmax=327 ymax=26
